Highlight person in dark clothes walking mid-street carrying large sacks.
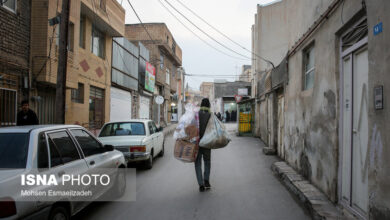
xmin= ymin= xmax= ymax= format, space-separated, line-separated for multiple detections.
xmin=195 ymin=98 xmax=211 ymax=192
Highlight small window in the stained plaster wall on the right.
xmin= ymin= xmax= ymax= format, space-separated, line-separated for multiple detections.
xmin=303 ymin=44 xmax=315 ymax=90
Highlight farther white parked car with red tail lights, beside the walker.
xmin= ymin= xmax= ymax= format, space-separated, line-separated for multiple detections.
xmin=98 ymin=119 xmax=164 ymax=169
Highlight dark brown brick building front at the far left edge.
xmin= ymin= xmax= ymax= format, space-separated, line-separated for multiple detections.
xmin=0 ymin=0 xmax=31 ymax=127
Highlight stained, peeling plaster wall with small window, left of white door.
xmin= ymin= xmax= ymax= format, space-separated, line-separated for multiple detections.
xmin=284 ymin=0 xmax=362 ymax=201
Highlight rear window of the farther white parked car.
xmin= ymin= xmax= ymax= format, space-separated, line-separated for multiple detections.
xmin=99 ymin=122 xmax=145 ymax=137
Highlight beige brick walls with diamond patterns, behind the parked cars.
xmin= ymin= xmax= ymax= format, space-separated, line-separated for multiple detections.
xmin=31 ymin=0 xmax=125 ymax=126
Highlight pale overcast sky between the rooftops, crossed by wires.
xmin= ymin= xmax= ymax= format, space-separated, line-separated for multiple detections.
xmin=118 ymin=0 xmax=273 ymax=89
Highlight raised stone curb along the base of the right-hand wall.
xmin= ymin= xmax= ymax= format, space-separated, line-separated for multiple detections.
xmin=271 ymin=161 xmax=356 ymax=220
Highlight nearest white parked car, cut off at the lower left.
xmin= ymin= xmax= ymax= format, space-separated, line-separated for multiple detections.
xmin=0 ymin=125 xmax=126 ymax=220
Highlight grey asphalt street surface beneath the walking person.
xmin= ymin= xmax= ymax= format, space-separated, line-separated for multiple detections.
xmin=74 ymin=124 xmax=310 ymax=220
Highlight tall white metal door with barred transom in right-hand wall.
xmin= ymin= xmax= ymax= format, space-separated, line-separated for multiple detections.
xmin=340 ymin=17 xmax=369 ymax=218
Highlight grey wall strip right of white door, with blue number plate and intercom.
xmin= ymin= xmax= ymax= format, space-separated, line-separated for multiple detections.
xmin=366 ymin=0 xmax=390 ymax=219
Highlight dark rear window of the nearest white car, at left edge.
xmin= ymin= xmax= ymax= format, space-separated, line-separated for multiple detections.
xmin=0 ymin=133 xmax=29 ymax=169
